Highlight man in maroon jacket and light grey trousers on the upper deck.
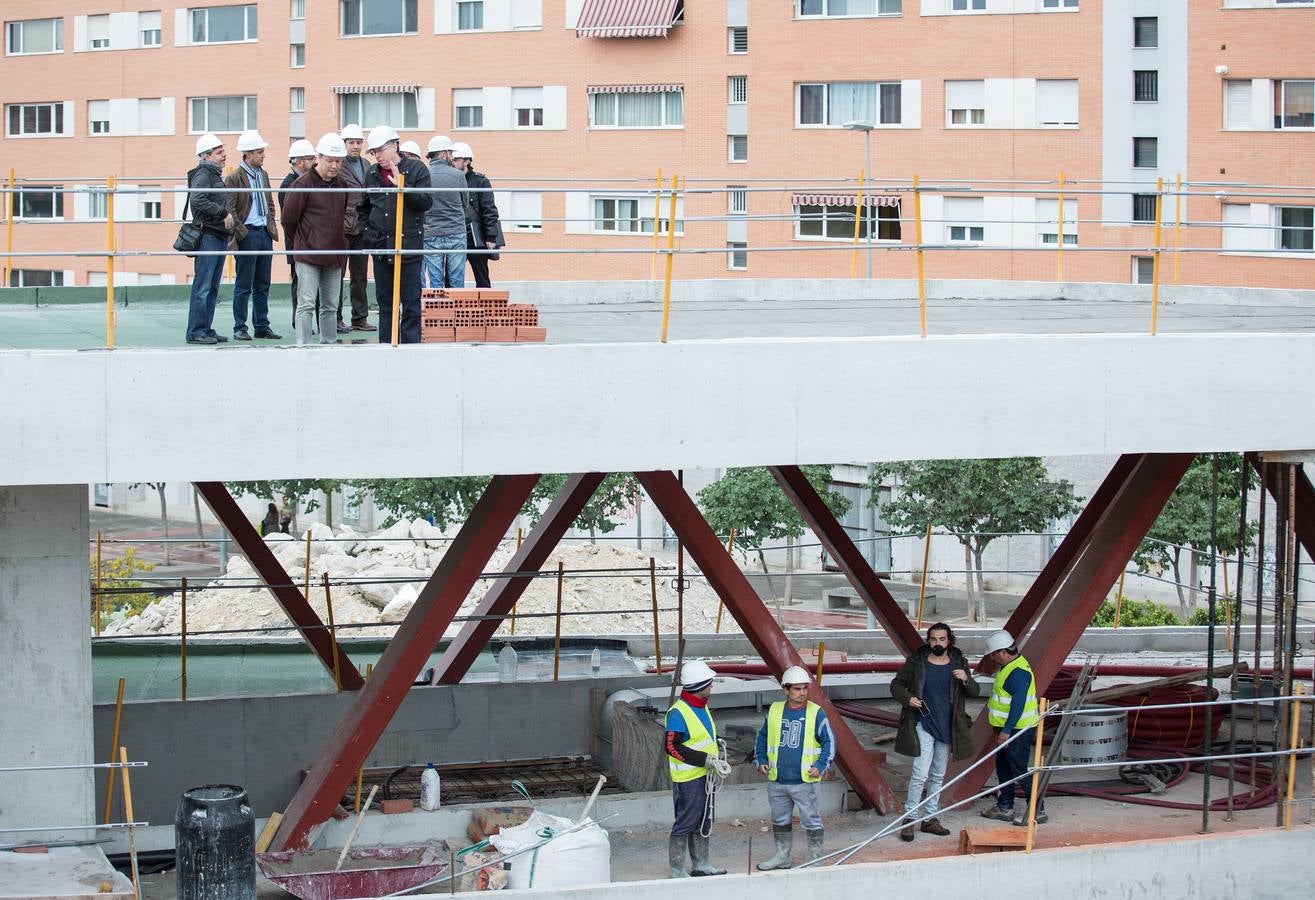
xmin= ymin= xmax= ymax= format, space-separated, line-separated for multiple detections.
xmin=283 ymin=132 xmax=348 ymax=343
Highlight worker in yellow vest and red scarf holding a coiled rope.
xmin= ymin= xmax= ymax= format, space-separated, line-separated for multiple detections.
xmin=667 ymin=661 xmax=730 ymax=878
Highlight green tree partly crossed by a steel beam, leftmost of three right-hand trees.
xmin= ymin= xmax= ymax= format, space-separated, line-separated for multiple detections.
xmin=698 ymin=466 xmax=851 ymax=603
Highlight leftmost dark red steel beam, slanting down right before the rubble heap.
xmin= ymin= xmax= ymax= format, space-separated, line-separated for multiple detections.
xmin=195 ymin=482 xmax=364 ymax=691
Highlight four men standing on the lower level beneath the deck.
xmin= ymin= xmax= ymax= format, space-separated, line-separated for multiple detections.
xmin=664 ymin=622 xmax=1048 ymax=878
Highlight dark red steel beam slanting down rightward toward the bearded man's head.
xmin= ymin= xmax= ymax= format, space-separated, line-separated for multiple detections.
xmin=768 ymin=466 xmax=922 ymax=657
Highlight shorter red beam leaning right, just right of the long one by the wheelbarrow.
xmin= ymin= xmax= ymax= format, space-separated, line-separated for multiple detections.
xmin=437 ymin=472 xmax=605 ymax=684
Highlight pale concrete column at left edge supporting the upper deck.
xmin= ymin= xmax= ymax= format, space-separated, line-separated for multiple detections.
xmin=0 ymin=484 xmax=96 ymax=842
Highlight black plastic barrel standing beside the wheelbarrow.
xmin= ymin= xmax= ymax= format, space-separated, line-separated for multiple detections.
xmin=174 ymin=784 xmax=255 ymax=900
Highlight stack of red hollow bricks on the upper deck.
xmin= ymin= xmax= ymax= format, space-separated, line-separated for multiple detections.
xmin=419 ymin=288 xmax=548 ymax=343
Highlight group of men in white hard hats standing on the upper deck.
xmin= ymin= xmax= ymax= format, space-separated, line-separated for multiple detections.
xmin=190 ymin=125 xmax=504 ymax=345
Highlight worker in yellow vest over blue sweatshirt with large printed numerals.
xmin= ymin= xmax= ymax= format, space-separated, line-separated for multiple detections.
xmin=755 ymin=666 xmax=835 ymax=871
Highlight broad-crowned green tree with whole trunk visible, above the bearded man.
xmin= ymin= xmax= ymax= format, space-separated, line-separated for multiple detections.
xmin=871 ymin=457 xmax=1081 ymax=622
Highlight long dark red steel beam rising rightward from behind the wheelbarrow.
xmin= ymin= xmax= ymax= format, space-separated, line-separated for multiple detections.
xmin=274 ymin=475 xmax=539 ymax=850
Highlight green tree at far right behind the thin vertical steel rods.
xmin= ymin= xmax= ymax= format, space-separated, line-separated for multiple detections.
xmin=1132 ymin=453 xmax=1258 ymax=620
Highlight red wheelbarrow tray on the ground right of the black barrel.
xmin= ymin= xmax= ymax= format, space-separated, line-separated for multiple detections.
xmin=255 ymin=845 xmax=448 ymax=900
